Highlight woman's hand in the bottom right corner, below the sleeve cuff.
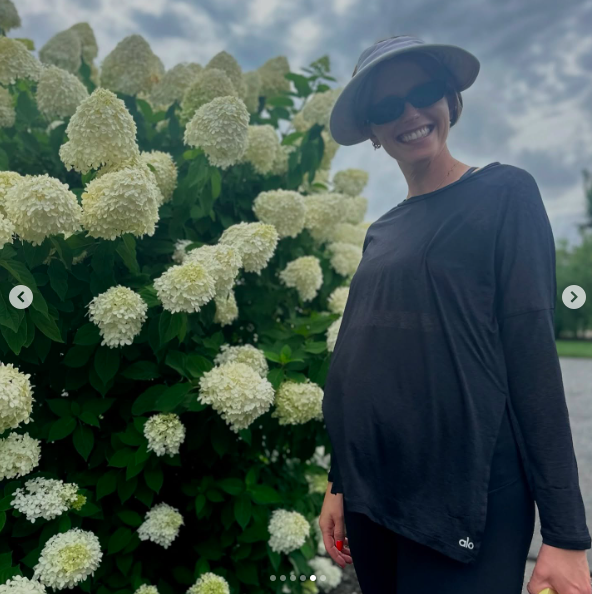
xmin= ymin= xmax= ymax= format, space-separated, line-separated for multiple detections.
xmin=526 ymin=544 xmax=592 ymax=594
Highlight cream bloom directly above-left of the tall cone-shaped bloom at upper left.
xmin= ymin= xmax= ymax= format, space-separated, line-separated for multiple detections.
xmin=36 ymin=66 xmax=88 ymax=120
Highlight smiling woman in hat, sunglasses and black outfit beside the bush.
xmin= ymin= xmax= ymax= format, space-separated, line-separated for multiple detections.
xmin=319 ymin=36 xmax=592 ymax=594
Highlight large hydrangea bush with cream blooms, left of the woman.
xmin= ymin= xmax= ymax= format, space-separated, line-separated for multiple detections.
xmin=0 ymin=5 xmax=368 ymax=594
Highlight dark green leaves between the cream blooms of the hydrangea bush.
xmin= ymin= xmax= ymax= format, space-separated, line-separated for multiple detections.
xmin=0 ymin=46 xmax=344 ymax=594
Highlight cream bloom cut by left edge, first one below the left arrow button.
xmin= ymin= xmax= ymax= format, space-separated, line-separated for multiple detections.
xmin=0 ymin=363 xmax=35 ymax=433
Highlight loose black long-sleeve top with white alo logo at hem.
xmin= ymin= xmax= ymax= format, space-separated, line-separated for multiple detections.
xmin=323 ymin=162 xmax=591 ymax=563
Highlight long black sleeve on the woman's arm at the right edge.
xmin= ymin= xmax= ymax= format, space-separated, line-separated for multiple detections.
xmin=495 ymin=170 xmax=592 ymax=550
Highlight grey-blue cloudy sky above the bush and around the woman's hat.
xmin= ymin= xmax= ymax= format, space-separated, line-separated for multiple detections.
xmin=11 ymin=0 xmax=592 ymax=243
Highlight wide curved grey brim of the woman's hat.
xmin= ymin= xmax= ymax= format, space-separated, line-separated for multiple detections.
xmin=329 ymin=43 xmax=481 ymax=146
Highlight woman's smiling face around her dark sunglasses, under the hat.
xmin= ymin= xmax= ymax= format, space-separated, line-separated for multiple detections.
xmin=370 ymin=58 xmax=450 ymax=163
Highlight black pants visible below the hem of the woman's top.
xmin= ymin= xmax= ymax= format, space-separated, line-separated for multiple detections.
xmin=344 ymin=404 xmax=535 ymax=594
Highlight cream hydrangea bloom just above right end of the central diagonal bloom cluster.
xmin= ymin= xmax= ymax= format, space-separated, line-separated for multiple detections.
xmin=253 ymin=188 xmax=306 ymax=238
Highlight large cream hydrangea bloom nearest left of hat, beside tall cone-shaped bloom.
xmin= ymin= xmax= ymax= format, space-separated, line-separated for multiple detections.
xmin=183 ymin=95 xmax=250 ymax=169
